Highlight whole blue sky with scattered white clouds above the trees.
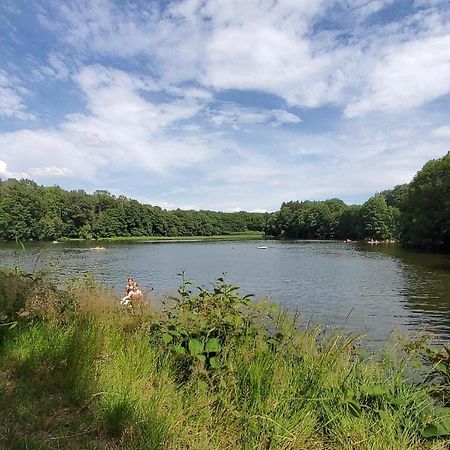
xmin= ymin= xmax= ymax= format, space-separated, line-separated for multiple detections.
xmin=0 ymin=0 xmax=450 ymax=211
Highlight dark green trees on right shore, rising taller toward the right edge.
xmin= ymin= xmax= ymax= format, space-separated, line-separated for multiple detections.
xmin=265 ymin=152 xmax=450 ymax=250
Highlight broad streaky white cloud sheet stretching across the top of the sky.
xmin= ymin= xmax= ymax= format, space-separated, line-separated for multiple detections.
xmin=37 ymin=0 xmax=450 ymax=117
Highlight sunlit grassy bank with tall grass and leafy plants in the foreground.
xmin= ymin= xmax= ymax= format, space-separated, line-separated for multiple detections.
xmin=0 ymin=272 xmax=449 ymax=450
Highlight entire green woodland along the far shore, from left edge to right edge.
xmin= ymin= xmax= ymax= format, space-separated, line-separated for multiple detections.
xmin=0 ymin=153 xmax=450 ymax=249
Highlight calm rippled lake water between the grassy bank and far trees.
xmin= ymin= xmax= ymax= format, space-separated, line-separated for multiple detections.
xmin=0 ymin=241 xmax=450 ymax=342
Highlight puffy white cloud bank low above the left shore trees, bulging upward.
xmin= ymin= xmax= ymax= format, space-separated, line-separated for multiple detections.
xmin=0 ymin=65 xmax=214 ymax=180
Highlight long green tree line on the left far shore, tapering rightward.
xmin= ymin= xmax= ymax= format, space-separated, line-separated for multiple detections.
xmin=0 ymin=179 xmax=265 ymax=241
